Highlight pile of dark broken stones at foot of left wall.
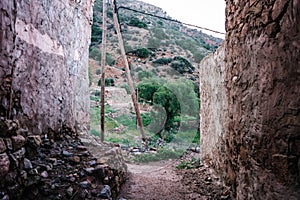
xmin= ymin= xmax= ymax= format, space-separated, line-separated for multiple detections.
xmin=0 ymin=118 xmax=127 ymax=200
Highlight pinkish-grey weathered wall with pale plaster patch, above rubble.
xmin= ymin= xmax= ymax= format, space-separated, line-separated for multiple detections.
xmin=0 ymin=0 xmax=92 ymax=134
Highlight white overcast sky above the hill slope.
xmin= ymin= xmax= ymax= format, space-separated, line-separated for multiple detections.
xmin=141 ymin=0 xmax=225 ymax=38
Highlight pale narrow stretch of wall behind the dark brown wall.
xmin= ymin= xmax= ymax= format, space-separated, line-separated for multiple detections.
xmin=199 ymin=45 xmax=227 ymax=173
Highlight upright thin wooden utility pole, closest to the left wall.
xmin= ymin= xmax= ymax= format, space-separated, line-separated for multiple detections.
xmin=100 ymin=0 xmax=107 ymax=142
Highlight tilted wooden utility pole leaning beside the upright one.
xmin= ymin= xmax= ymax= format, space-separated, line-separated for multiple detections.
xmin=110 ymin=0 xmax=146 ymax=140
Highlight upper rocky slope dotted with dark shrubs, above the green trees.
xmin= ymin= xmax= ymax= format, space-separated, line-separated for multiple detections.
xmin=90 ymin=0 xmax=222 ymax=86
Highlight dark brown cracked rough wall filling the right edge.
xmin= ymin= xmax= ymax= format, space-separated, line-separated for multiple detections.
xmin=224 ymin=0 xmax=300 ymax=199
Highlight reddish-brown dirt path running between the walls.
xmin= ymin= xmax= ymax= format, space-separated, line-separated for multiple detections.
xmin=121 ymin=161 xmax=230 ymax=200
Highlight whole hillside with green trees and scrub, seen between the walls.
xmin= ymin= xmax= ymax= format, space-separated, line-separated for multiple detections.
xmin=89 ymin=0 xmax=222 ymax=145
